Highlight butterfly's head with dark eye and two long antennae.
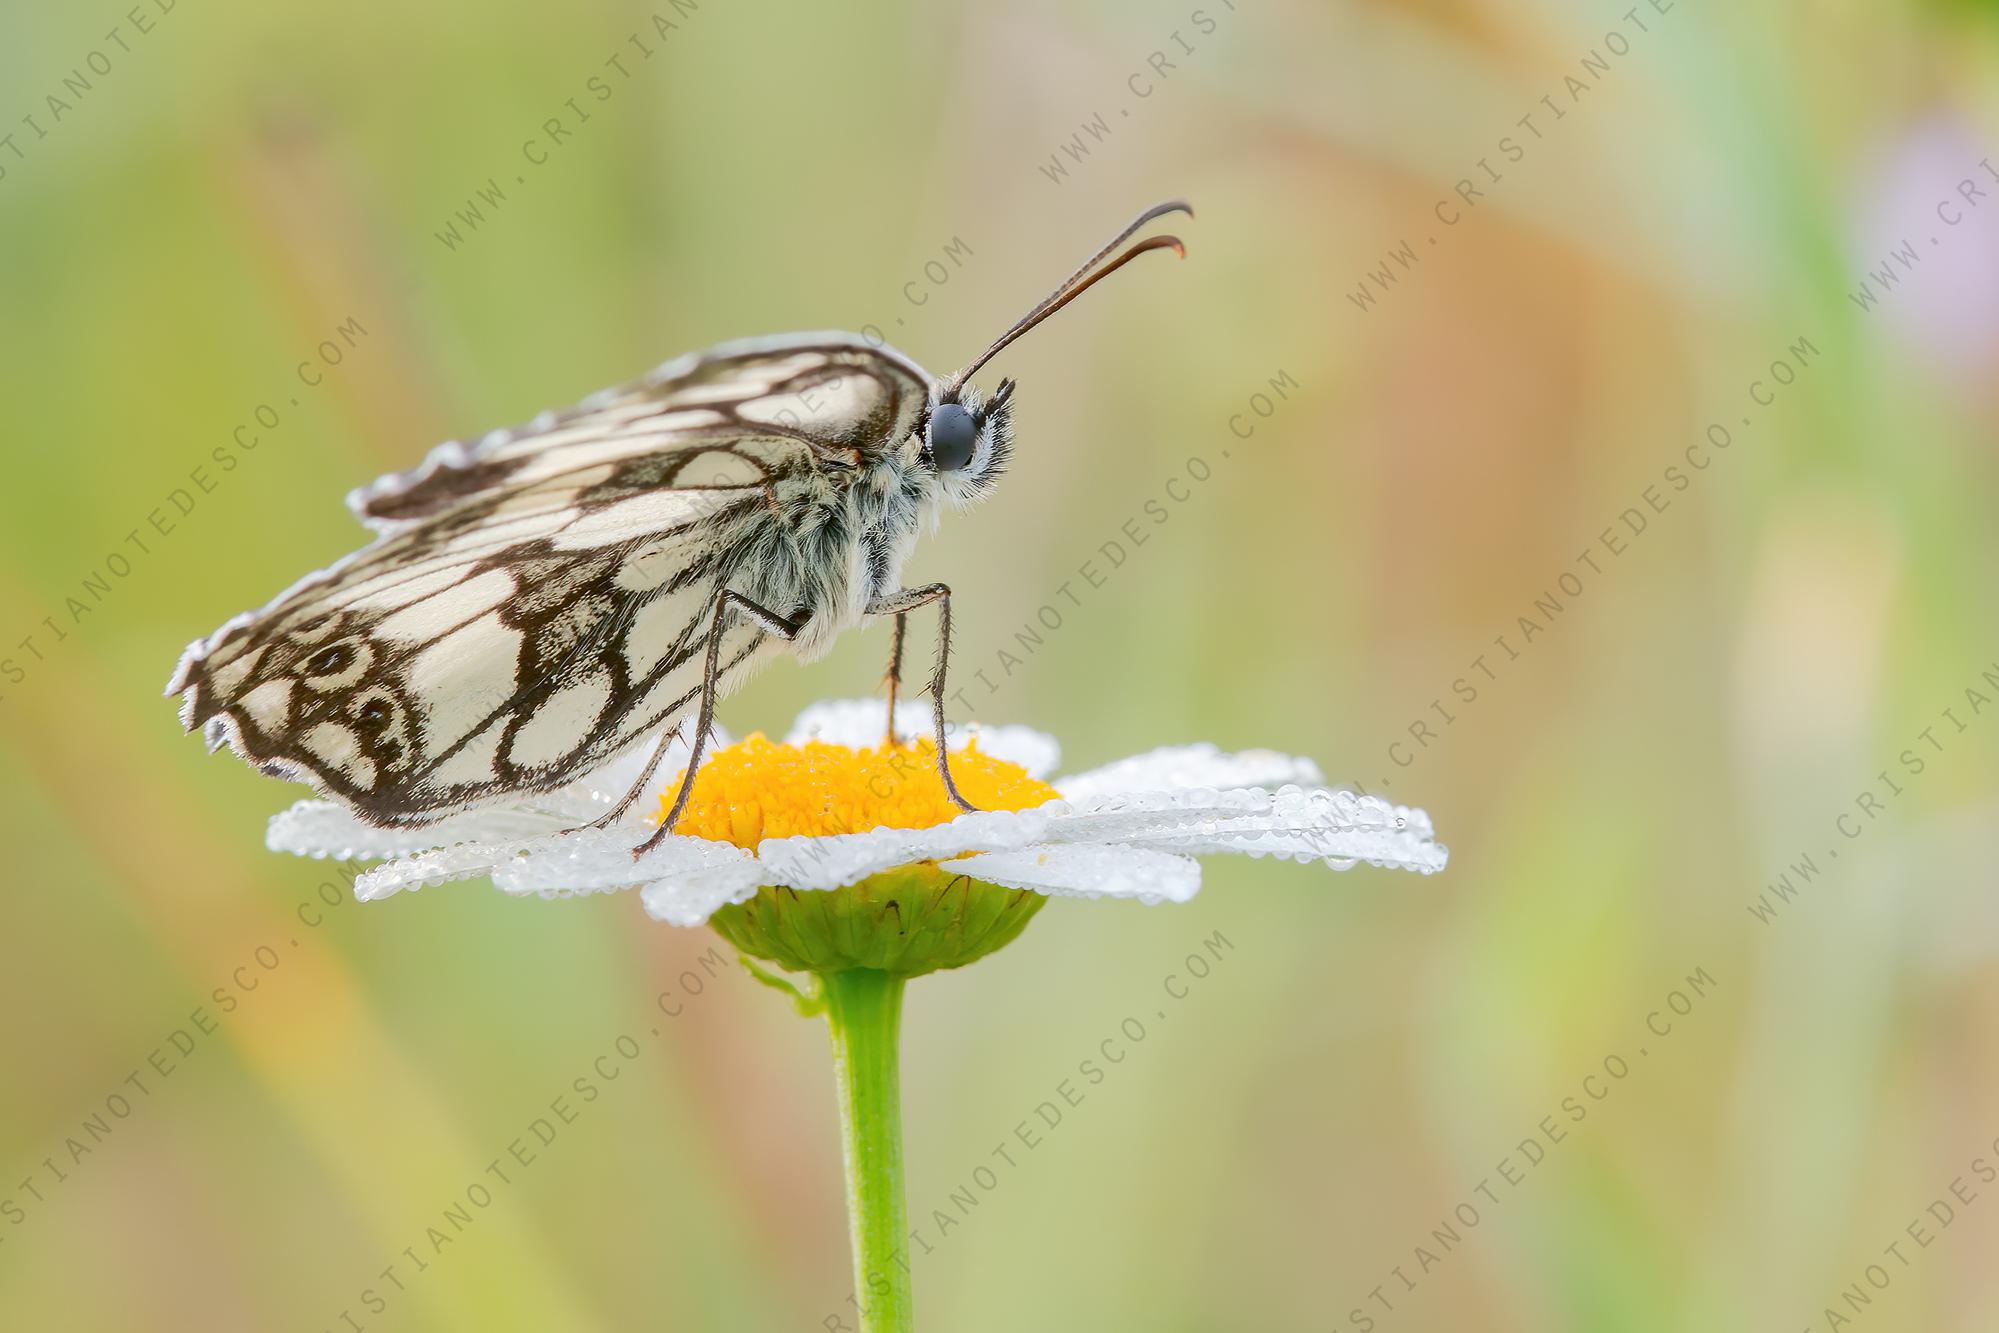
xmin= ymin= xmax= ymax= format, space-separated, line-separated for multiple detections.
xmin=922 ymin=200 xmax=1193 ymax=504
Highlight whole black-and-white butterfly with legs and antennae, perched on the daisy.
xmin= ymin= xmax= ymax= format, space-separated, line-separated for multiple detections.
xmin=166 ymin=200 xmax=1193 ymax=845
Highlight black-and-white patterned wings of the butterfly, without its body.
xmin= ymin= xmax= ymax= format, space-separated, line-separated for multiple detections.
xmin=168 ymin=334 xmax=930 ymax=825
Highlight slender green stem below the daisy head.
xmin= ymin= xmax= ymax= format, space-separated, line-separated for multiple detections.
xmin=822 ymin=967 xmax=916 ymax=1333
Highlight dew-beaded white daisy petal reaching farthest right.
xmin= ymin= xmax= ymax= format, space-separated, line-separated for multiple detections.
xmin=1047 ymin=787 xmax=1449 ymax=873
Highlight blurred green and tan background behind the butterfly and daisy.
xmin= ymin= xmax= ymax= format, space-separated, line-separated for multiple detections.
xmin=0 ymin=0 xmax=1999 ymax=1333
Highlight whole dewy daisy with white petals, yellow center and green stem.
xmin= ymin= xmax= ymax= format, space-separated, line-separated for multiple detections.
xmin=268 ymin=699 xmax=1447 ymax=1333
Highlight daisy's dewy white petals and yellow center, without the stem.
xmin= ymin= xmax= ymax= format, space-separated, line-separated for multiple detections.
xmin=268 ymin=699 xmax=1445 ymax=947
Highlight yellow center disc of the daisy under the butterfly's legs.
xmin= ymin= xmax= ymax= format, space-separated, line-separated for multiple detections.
xmin=660 ymin=733 xmax=1059 ymax=851
